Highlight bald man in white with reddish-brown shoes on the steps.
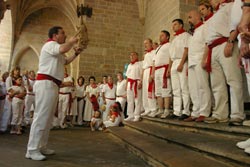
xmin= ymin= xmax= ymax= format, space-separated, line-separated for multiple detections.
xmin=184 ymin=10 xmax=211 ymax=122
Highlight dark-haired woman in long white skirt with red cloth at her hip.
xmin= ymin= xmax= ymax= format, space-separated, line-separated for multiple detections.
xmin=83 ymin=76 xmax=100 ymax=122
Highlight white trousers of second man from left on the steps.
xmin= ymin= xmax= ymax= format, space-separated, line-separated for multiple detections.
xmin=142 ymin=68 xmax=157 ymax=112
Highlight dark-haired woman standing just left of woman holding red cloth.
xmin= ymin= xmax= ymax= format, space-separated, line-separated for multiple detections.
xmin=76 ymin=76 xmax=86 ymax=125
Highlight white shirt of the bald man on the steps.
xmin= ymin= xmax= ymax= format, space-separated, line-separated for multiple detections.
xmin=188 ymin=24 xmax=205 ymax=67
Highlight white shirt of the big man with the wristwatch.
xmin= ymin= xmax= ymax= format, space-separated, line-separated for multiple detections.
xmin=206 ymin=3 xmax=233 ymax=45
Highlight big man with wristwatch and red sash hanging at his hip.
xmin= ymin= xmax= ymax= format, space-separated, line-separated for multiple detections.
xmin=205 ymin=0 xmax=245 ymax=125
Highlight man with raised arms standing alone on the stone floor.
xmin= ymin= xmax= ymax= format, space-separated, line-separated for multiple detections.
xmin=25 ymin=26 xmax=82 ymax=160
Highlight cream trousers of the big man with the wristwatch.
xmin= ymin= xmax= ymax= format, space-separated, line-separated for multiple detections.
xmin=210 ymin=43 xmax=245 ymax=119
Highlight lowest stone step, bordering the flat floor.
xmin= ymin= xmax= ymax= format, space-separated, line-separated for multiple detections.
xmin=109 ymin=127 xmax=236 ymax=167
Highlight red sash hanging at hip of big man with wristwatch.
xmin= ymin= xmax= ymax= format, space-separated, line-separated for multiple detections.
xmin=207 ymin=37 xmax=228 ymax=73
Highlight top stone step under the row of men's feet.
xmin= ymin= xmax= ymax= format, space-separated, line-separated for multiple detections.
xmin=143 ymin=117 xmax=250 ymax=140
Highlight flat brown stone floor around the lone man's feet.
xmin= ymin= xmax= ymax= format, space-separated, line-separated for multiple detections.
xmin=0 ymin=127 xmax=147 ymax=167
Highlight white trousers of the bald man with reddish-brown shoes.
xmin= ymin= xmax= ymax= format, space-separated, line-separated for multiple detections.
xmin=188 ymin=64 xmax=211 ymax=118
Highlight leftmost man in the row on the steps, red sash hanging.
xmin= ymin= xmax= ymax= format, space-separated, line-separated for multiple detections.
xmin=125 ymin=52 xmax=142 ymax=122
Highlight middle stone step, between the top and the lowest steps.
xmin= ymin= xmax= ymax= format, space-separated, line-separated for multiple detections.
xmin=122 ymin=121 xmax=250 ymax=166
